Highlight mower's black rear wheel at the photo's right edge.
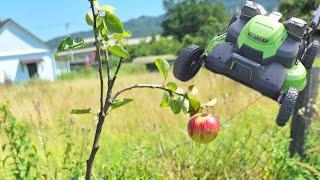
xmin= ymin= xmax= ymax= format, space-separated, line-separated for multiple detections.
xmin=302 ymin=41 xmax=320 ymax=70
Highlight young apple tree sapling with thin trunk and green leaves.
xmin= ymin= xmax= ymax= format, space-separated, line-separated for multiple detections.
xmin=58 ymin=0 xmax=218 ymax=179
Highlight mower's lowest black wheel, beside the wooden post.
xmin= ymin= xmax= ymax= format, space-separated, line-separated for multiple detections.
xmin=277 ymin=88 xmax=299 ymax=126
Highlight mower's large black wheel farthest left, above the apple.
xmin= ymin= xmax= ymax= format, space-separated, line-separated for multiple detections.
xmin=173 ymin=45 xmax=204 ymax=82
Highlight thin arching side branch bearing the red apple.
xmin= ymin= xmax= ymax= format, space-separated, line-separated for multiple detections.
xmin=112 ymin=84 xmax=186 ymax=101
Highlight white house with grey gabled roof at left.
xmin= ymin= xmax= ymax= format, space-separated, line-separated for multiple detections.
xmin=0 ymin=19 xmax=57 ymax=83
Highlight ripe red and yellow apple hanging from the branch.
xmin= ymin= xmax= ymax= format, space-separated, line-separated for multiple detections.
xmin=188 ymin=113 xmax=220 ymax=144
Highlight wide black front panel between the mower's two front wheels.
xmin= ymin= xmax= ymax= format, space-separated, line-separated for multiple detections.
xmin=205 ymin=43 xmax=286 ymax=100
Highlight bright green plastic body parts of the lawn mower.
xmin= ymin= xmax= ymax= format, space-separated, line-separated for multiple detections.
xmin=204 ymin=15 xmax=307 ymax=93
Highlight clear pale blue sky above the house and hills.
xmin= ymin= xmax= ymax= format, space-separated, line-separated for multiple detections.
xmin=0 ymin=0 xmax=164 ymax=40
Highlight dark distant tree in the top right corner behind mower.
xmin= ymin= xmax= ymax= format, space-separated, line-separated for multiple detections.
xmin=279 ymin=0 xmax=320 ymax=21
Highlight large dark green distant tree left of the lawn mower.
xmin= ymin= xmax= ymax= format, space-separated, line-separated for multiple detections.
xmin=162 ymin=0 xmax=228 ymax=40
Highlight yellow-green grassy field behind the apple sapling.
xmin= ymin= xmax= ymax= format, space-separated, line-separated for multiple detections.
xmin=0 ymin=70 xmax=320 ymax=179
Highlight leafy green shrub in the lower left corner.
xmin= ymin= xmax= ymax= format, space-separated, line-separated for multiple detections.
xmin=0 ymin=104 xmax=44 ymax=179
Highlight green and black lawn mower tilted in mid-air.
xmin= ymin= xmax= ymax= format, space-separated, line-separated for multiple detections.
xmin=173 ymin=1 xmax=320 ymax=126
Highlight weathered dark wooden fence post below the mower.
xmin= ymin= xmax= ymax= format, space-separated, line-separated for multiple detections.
xmin=289 ymin=68 xmax=320 ymax=157
